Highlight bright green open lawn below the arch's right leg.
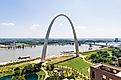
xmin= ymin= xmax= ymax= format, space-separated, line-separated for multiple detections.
xmin=58 ymin=57 xmax=91 ymax=76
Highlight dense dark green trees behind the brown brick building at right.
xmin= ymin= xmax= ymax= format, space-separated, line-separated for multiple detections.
xmin=86 ymin=47 xmax=121 ymax=65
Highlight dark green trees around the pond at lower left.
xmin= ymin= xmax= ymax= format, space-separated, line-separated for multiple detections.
xmin=2 ymin=63 xmax=45 ymax=80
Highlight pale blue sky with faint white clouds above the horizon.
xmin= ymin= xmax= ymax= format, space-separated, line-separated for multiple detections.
xmin=0 ymin=0 xmax=121 ymax=38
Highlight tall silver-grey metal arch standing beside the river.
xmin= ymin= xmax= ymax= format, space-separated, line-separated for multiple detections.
xmin=41 ymin=14 xmax=79 ymax=62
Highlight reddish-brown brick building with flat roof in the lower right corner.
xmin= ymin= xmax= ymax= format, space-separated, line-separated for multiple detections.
xmin=90 ymin=64 xmax=121 ymax=80
